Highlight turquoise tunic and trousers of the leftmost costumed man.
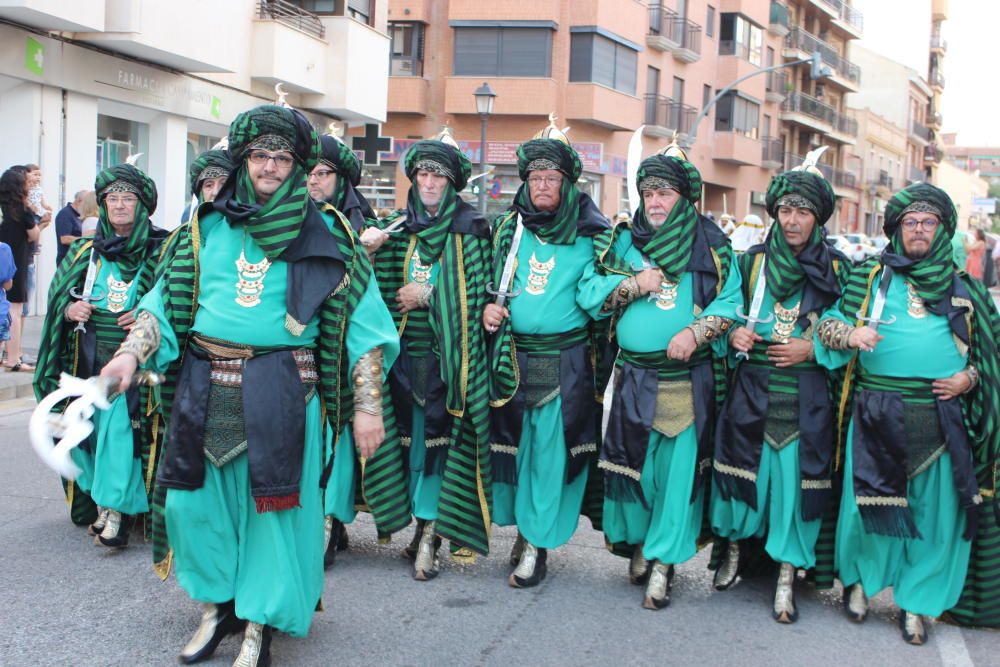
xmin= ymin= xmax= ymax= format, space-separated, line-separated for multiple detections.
xmin=64 ymin=260 xmax=149 ymax=515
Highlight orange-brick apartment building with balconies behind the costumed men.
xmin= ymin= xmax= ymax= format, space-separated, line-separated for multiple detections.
xmin=378 ymin=0 xmax=861 ymax=224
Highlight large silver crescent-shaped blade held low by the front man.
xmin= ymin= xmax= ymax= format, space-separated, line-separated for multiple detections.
xmin=28 ymin=371 xmax=164 ymax=479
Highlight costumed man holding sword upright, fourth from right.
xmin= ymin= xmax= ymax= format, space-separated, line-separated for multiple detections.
xmin=483 ymin=119 xmax=640 ymax=588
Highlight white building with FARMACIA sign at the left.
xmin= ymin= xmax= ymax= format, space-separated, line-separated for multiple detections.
xmin=0 ymin=0 xmax=389 ymax=312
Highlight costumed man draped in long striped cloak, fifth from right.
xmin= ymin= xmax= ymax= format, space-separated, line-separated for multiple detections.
xmin=362 ymin=128 xmax=492 ymax=581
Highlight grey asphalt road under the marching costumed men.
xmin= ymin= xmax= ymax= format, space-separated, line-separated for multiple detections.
xmin=0 ymin=401 xmax=1000 ymax=667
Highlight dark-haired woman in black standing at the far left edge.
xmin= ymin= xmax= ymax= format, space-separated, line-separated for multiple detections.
xmin=0 ymin=167 xmax=39 ymax=372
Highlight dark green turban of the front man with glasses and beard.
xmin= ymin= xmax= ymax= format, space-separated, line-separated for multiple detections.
xmin=229 ymin=104 xmax=323 ymax=172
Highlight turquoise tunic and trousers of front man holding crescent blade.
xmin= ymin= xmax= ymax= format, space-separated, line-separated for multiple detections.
xmin=140 ymin=213 xmax=398 ymax=636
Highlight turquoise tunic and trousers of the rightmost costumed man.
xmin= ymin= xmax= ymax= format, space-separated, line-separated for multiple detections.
xmin=816 ymin=275 xmax=971 ymax=616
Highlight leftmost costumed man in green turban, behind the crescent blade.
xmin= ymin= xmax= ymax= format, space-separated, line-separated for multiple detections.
xmin=35 ymin=164 xmax=166 ymax=547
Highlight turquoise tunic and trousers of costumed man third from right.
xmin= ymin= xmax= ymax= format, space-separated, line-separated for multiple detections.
xmin=604 ymin=231 xmax=741 ymax=563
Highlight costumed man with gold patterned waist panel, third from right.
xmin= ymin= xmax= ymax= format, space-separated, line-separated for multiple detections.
xmin=599 ymin=144 xmax=740 ymax=610
